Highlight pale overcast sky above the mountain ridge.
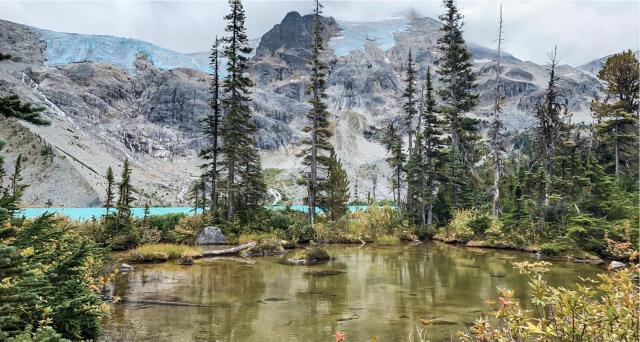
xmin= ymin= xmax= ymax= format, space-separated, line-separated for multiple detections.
xmin=0 ymin=0 xmax=640 ymax=65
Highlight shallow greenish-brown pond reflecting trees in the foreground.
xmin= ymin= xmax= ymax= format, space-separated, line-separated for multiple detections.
xmin=105 ymin=242 xmax=603 ymax=342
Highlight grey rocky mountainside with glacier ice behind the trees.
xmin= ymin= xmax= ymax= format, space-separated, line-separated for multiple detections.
xmin=0 ymin=12 xmax=599 ymax=205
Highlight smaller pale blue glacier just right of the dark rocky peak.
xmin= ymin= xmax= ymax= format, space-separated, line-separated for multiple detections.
xmin=329 ymin=18 xmax=411 ymax=57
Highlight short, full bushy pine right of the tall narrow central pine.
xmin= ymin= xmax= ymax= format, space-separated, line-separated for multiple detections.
xmin=318 ymin=150 xmax=350 ymax=221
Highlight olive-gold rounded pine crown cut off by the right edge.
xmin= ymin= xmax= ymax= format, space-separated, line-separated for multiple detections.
xmin=591 ymin=50 xmax=640 ymax=180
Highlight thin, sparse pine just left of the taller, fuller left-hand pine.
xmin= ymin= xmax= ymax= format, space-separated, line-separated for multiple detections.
xmin=200 ymin=37 xmax=222 ymax=213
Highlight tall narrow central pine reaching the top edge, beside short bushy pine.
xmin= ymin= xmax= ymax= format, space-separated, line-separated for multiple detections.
xmin=302 ymin=0 xmax=333 ymax=224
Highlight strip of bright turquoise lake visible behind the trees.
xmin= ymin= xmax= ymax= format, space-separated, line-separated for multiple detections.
xmin=20 ymin=205 xmax=367 ymax=220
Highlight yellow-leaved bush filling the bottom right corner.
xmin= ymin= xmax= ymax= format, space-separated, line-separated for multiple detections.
xmin=459 ymin=255 xmax=640 ymax=342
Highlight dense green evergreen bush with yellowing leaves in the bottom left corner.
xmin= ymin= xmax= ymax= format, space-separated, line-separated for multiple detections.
xmin=0 ymin=215 xmax=109 ymax=341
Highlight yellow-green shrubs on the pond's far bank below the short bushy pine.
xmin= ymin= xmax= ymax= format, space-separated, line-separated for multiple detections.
xmin=314 ymin=206 xmax=415 ymax=243
